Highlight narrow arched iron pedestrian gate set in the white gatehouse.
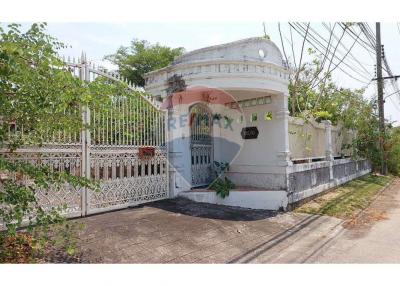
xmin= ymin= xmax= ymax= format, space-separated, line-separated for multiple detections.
xmin=190 ymin=104 xmax=213 ymax=187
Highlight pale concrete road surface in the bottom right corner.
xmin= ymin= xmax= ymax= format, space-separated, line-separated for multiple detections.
xmin=306 ymin=178 xmax=400 ymax=263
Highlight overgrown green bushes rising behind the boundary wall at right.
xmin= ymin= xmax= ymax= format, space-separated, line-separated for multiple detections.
xmin=289 ymin=49 xmax=400 ymax=174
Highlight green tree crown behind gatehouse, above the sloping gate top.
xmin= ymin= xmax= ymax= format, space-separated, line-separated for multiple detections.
xmin=105 ymin=39 xmax=184 ymax=86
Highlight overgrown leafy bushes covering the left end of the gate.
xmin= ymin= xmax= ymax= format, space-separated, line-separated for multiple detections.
xmin=0 ymin=23 xmax=138 ymax=262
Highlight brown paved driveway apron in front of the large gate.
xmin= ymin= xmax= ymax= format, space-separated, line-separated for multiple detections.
xmin=76 ymin=198 xmax=346 ymax=263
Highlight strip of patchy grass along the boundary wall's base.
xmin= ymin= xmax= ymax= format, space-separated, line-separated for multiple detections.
xmin=294 ymin=175 xmax=392 ymax=219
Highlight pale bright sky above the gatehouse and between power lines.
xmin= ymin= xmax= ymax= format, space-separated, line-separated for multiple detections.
xmin=8 ymin=22 xmax=400 ymax=124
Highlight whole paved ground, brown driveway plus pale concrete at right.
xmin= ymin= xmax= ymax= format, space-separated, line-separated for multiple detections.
xmin=76 ymin=179 xmax=400 ymax=263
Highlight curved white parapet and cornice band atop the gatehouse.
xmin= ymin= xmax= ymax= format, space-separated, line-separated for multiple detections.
xmin=145 ymin=38 xmax=289 ymax=100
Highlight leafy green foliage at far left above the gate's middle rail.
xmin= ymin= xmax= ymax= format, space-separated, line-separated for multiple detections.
xmin=0 ymin=24 xmax=85 ymax=149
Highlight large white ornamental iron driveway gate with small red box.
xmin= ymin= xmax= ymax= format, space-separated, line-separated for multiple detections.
xmin=0 ymin=55 xmax=169 ymax=217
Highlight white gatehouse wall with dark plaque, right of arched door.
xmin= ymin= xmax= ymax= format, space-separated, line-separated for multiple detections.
xmin=214 ymin=90 xmax=287 ymax=190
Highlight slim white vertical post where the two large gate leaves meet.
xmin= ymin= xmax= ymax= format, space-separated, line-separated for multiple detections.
xmin=79 ymin=53 xmax=90 ymax=216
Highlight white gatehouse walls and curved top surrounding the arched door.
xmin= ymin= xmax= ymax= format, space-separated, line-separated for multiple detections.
xmin=146 ymin=38 xmax=290 ymax=196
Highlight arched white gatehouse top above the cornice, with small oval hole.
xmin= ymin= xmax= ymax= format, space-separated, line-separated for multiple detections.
xmin=172 ymin=37 xmax=283 ymax=66
